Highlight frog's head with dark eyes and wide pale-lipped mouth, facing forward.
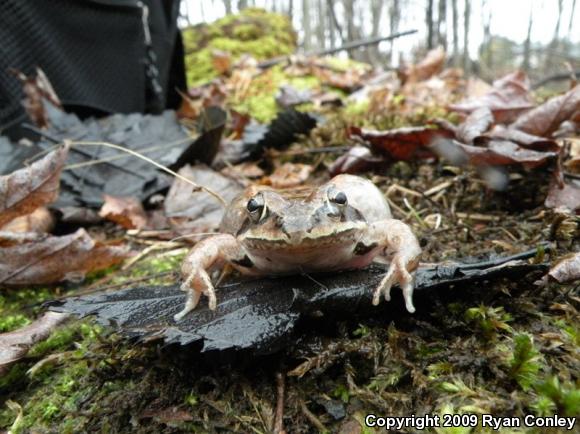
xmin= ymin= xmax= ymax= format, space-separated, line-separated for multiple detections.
xmin=226 ymin=184 xmax=366 ymax=249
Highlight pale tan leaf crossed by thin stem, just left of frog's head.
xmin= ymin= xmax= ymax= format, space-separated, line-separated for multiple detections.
xmin=164 ymin=165 xmax=242 ymax=236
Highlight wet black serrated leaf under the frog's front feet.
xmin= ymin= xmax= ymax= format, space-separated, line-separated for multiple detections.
xmin=50 ymin=250 xmax=547 ymax=353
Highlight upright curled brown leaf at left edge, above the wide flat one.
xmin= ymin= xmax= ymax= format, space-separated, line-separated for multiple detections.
xmin=0 ymin=146 xmax=68 ymax=227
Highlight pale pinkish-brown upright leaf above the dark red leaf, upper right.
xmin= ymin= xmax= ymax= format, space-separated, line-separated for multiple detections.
xmin=449 ymin=71 xmax=535 ymax=123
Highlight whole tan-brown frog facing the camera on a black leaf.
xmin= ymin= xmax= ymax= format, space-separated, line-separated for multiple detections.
xmin=175 ymin=175 xmax=421 ymax=321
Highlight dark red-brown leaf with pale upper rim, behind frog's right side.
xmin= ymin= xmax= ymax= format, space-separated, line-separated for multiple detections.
xmin=348 ymin=127 xmax=455 ymax=160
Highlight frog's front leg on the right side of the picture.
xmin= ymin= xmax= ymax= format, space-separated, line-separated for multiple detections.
xmin=365 ymin=219 xmax=421 ymax=313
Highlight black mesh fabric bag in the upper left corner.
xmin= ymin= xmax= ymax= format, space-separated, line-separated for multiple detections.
xmin=0 ymin=0 xmax=185 ymax=132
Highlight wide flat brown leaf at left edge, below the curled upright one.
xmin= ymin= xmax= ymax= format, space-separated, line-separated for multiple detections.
xmin=0 ymin=229 xmax=131 ymax=287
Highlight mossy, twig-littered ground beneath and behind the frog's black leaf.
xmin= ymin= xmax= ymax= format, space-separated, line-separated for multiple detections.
xmin=0 ymin=154 xmax=580 ymax=433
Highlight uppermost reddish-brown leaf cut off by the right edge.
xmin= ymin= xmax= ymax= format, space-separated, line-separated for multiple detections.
xmin=511 ymin=86 xmax=580 ymax=137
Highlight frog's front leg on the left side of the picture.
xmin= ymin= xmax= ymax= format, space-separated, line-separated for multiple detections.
xmin=174 ymin=234 xmax=241 ymax=321
